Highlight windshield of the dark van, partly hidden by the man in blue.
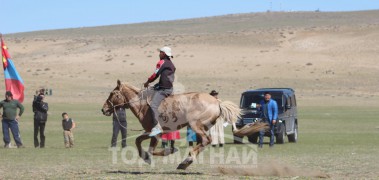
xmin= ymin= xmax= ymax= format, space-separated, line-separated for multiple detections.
xmin=240 ymin=92 xmax=283 ymax=111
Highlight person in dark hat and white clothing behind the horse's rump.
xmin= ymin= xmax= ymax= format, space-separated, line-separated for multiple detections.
xmin=209 ymin=90 xmax=225 ymax=147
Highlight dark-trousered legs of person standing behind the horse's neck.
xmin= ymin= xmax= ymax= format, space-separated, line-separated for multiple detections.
xmin=111 ymin=107 xmax=127 ymax=148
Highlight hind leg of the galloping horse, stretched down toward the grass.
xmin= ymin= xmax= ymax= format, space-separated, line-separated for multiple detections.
xmin=176 ymin=124 xmax=211 ymax=170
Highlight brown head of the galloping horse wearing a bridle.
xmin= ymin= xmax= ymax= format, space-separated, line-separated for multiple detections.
xmin=101 ymin=80 xmax=127 ymax=116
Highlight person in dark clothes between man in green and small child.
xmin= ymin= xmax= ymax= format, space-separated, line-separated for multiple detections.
xmin=33 ymin=94 xmax=49 ymax=148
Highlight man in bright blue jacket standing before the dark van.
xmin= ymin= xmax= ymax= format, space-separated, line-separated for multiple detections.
xmin=258 ymin=92 xmax=278 ymax=148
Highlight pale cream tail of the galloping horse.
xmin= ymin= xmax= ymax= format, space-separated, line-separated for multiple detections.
xmin=220 ymin=101 xmax=242 ymax=125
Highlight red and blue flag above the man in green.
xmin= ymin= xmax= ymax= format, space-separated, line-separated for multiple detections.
xmin=1 ymin=38 xmax=24 ymax=103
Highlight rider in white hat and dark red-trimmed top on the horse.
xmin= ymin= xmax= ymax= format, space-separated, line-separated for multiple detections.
xmin=144 ymin=46 xmax=176 ymax=137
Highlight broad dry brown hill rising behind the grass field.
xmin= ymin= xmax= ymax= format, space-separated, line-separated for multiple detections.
xmin=4 ymin=11 xmax=379 ymax=105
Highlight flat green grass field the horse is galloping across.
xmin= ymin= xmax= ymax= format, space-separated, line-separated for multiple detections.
xmin=0 ymin=104 xmax=379 ymax=179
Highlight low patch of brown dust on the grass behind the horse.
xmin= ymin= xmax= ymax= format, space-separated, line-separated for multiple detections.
xmin=217 ymin=161 xmax=330 ymax=178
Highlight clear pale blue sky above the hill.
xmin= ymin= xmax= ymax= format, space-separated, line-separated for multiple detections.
xmin=0 ymin=0 xmax=379 ymax=34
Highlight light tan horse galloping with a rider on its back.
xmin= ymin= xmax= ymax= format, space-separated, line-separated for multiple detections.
xmin=102 ymin=80 xmax=241 ymax=169
